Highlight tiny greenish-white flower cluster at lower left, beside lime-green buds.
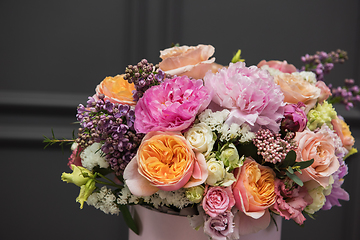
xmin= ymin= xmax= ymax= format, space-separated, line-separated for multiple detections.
xmin=86 ymin=186 xmax=120 ymax=215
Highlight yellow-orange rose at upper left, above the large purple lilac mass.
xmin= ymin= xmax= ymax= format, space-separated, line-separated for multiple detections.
xmin=95 ymin=74 xmax=136 ymax=105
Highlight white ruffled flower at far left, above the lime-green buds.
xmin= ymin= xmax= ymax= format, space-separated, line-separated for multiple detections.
xmin=80 ymin=143 xmax=109 ymax=171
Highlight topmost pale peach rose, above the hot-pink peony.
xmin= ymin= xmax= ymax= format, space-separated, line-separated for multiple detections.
xmin=159 ymin=44 xmax=217 ymax=79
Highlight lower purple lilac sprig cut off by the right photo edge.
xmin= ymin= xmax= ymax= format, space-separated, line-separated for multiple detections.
xmin=327 ymin=79 xmax=360 ymax=110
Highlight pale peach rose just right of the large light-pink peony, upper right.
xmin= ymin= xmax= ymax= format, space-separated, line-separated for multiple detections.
xmin=274 ymin=73 xmax=321 ymax=113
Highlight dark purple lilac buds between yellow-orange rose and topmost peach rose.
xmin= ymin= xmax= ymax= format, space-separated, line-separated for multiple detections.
xmin=124 ymin=59 xmax=170 ymax=101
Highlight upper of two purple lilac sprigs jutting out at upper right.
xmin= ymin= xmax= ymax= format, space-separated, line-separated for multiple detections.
xmin=301 ymin=49 xmax=348 ymax=81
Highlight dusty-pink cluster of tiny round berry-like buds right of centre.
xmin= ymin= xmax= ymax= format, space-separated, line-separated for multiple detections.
xmin=253 ymin=128 xmax=296 ymax=164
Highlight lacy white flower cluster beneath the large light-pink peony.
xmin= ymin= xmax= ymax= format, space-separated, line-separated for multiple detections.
xmin=199 ymin=109 xmax=255 ymax=143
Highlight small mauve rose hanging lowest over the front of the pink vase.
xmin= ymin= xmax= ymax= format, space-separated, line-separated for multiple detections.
xmin=204 ymin=212 xmax=234 ymax=240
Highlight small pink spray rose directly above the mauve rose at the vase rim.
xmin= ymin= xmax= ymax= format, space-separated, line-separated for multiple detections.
xmin=202 ymin=187 xmax=235 ymax=217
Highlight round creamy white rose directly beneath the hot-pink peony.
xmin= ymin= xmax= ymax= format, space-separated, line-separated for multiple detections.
xmin=185 ymin=123 xmax=215 ymax=156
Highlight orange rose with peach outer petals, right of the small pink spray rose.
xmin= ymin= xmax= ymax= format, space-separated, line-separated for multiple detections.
xmin=232 ymin=157 xmax=276 ymax=219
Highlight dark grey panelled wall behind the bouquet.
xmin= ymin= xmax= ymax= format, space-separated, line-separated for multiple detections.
xmin=0 ymin=0 xmax=360 ymax=240
